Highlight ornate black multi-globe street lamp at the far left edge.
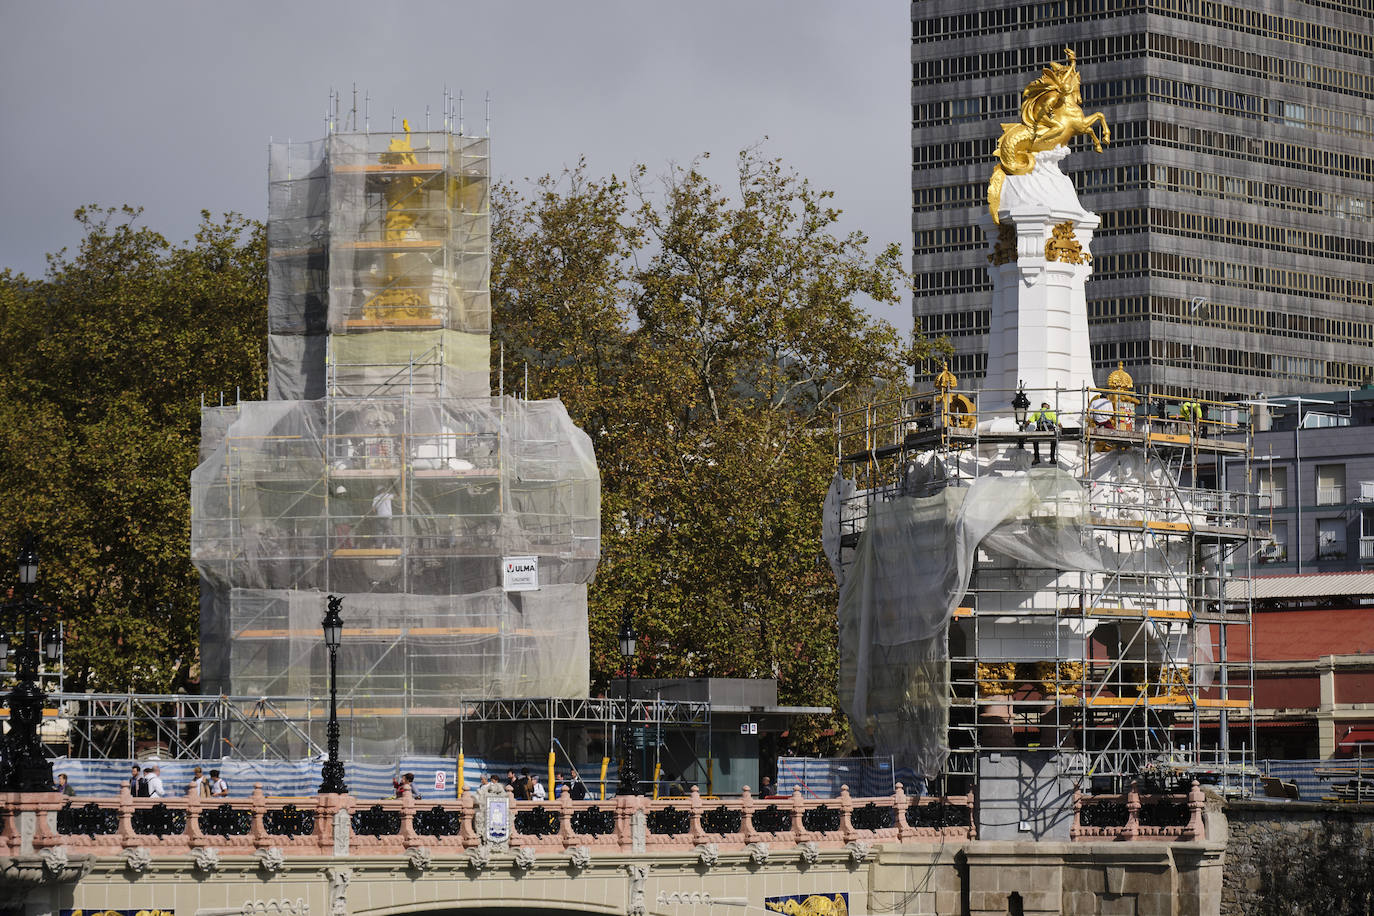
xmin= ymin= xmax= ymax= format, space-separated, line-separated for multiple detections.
xmin=0 ymin=537 xmax=62 ymax=792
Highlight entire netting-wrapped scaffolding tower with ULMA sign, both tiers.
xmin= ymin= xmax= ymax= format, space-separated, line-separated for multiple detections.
xmin=191 ymin=114 xmax=600 ymax=757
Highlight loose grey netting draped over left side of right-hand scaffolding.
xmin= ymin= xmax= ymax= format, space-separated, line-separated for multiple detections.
xmin=840 ymin=470 xmax=1101 ymax=777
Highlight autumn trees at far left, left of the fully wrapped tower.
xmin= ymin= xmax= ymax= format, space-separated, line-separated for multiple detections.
xmin=0 ymin=207 xmax=267 ymax=692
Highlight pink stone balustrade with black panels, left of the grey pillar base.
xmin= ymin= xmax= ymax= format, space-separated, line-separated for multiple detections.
xmin=0 ymin=783 xmax=976 ymax=856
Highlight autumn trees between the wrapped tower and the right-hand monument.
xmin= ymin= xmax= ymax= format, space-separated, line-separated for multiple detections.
xmin=492 ymin=150 xmax=925 ymax=739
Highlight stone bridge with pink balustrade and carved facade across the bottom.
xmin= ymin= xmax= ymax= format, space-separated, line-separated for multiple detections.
xmin=0 ymin=786 xmax=1224 ymax=916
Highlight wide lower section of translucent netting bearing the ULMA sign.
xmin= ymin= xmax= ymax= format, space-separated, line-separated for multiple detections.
xmin=191 ymin=397 xmax=600 ymax=699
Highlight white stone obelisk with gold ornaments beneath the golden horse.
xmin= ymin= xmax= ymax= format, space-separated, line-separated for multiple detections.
xmin=981 ymin=147 xmax=1099 ymax=402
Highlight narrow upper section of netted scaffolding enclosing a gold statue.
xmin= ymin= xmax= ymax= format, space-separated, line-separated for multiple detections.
xmin=268 ymin=122 xmax=491 ymax=400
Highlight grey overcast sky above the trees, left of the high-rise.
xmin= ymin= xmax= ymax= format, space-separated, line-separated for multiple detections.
xmin=0 ymin=0 xmax=911 ymax=336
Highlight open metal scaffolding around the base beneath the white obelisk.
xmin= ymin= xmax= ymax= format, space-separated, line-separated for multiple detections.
xmin=824 ymin=372 xmax=1267 ymax=786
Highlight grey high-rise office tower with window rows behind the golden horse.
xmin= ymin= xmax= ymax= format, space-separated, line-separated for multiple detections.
xmin=911 ymin=0 xmax=1374 ymax=397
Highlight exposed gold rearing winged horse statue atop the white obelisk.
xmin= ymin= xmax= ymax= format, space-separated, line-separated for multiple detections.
xmin=988 ymin=48 xmax=1112 ymax=224
